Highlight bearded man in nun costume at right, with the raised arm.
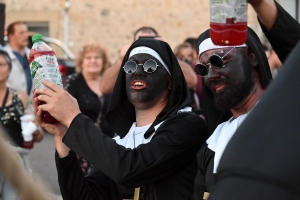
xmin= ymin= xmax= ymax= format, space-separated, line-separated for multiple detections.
xmin=194 ymin=0 xmax=300 ymax=200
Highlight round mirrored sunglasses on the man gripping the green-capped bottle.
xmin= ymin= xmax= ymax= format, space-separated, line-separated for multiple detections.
xmin=123 ymin=59 xmax=159 ymax=74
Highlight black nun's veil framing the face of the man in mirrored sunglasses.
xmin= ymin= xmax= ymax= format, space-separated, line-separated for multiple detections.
xmin=106 ymin=39 xmax=191 ymax=138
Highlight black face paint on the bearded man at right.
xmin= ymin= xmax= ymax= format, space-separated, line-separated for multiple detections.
xmin=205 ymin=48 xmax=254 ymax=110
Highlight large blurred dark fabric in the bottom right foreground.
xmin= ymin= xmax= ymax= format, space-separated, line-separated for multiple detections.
xmin=209 ymin=43 xmax=300 ymax=200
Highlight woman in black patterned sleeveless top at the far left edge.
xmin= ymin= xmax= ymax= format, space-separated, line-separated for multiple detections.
xmin=0 ymin=50 xmax=44 ymax=200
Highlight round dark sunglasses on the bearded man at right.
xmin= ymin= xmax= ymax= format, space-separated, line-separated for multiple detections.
xmin=194 ymin=47 xmax=235 ymax=76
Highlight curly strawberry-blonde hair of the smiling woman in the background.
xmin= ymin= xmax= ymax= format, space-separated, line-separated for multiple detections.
xmin=75 ymin=42 xmax=109 ymax=75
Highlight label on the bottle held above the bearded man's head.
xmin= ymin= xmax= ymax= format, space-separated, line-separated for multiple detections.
xmin=210 ymin=0 xmax=247 ymax=24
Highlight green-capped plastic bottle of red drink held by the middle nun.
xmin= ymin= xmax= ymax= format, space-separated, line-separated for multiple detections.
xmin=29 ymin=34 xmax=62 ymax=124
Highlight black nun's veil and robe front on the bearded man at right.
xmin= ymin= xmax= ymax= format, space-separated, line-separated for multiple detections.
xmin=194 ymin=28 xmax=272 ymax=199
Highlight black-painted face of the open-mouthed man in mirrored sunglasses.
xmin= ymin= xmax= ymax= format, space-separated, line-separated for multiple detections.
xmin=125 ymin=54 xmax=169 ymax=108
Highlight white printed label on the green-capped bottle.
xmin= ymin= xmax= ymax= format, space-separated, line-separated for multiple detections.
xmin=30 ymin=55 xmax=62 ymax=89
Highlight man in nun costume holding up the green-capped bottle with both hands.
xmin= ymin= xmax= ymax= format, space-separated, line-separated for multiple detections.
xmin=34 ymin=39 xmax=207 ymax=200
